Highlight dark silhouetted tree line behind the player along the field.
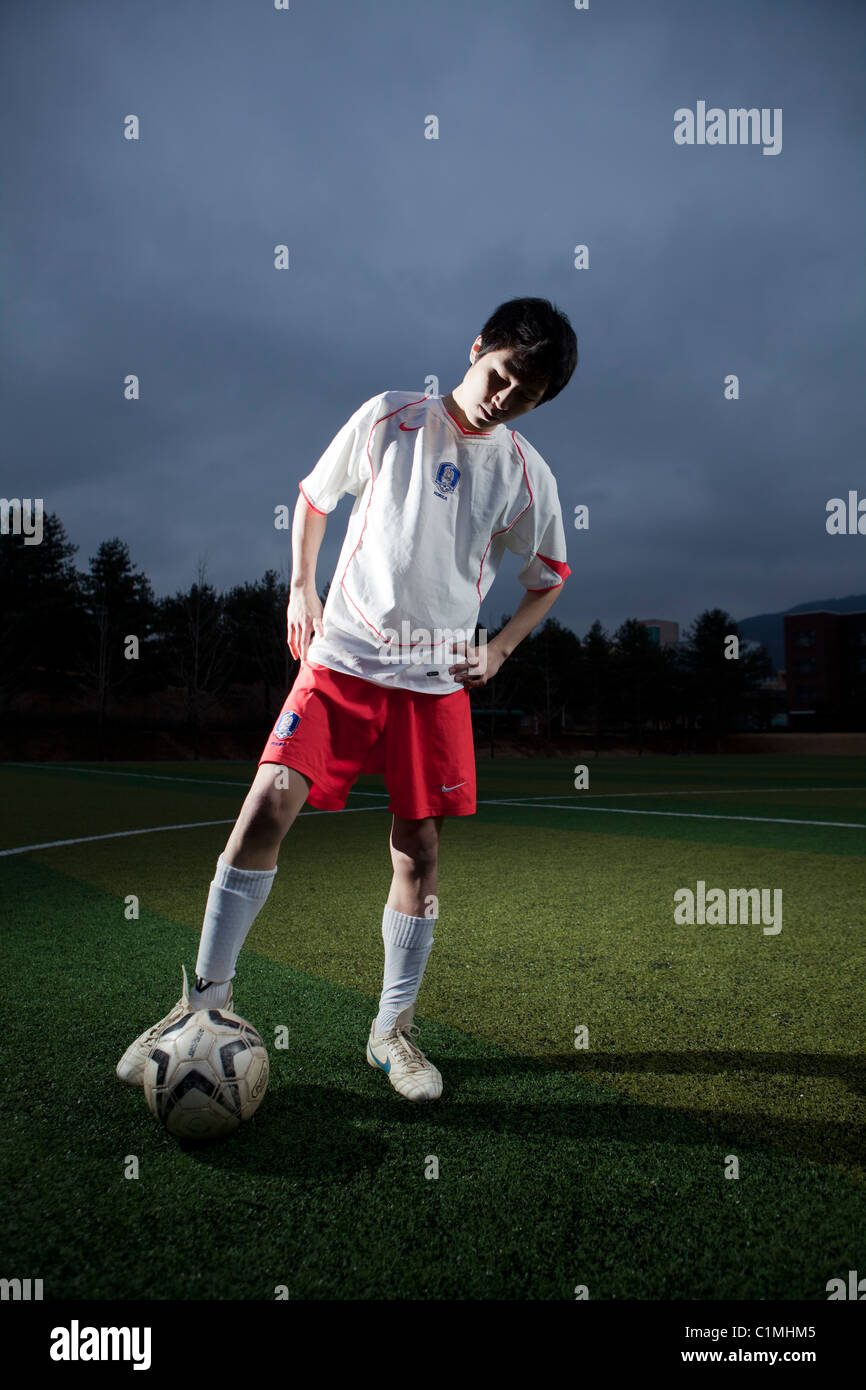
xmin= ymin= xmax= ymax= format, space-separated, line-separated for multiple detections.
xmin=0 ymin=513 xmax=776 ymax=755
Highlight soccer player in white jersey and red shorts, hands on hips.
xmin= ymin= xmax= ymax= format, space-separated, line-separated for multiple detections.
xmin=117 ymin=299 xmax=577 ymax=1101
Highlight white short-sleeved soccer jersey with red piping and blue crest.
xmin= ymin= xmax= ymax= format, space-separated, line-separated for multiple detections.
xmin=299 ymin=391 xmax=571 ymax=695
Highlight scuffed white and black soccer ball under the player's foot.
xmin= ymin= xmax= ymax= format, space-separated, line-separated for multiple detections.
xmin=145 ymin=1009 xmax=268 ymax=1138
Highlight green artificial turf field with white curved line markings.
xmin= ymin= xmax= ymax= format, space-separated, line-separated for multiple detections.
xmin=0 ymin=756 xmax=866 ymax=1300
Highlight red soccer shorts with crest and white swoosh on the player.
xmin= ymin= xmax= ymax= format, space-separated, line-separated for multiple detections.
xmin=259 ymin=662 xmax=475 ymax=820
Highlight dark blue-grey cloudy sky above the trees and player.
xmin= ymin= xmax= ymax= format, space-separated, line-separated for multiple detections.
xmin=0 ymin=0 xmax=866 ymax=634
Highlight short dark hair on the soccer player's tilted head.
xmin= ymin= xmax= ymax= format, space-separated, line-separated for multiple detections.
xmin=475 ymin=299 xmax=577 ymax=406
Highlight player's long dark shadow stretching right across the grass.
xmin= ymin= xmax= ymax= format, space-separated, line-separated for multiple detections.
xmin=111 ymin=1041 xmax=866 ymax=1183
